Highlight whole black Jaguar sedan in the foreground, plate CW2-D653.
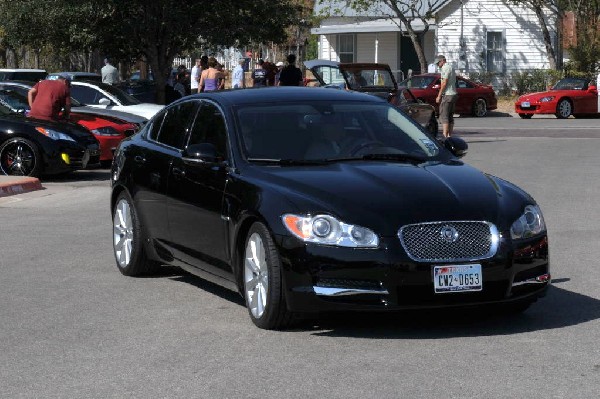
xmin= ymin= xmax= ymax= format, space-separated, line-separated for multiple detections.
xmin=111 ymin=87 xmax=550 ymax=329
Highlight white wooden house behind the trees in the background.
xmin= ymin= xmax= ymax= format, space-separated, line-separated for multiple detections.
xmin=312 ymin=0 xmax=558 ymax=85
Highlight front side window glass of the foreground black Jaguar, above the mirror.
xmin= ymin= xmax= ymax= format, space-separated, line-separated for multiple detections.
xmin=189 ymin=103 xmax=227 ymax=159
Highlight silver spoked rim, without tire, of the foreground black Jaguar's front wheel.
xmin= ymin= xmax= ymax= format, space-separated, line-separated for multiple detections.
xmin=244 ymin=233 xmax=269 ymax=319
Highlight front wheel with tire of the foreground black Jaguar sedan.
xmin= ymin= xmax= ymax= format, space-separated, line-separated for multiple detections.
xmin=243 ymin=222 xmax=293 ymax=330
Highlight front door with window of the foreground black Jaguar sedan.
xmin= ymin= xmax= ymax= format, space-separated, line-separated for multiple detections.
xmin=168 ymin=101 xmax=232 ymax=279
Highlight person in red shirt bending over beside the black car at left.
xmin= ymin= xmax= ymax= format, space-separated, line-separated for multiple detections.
xmin=27 ymin=76 xmax=71 ymax=121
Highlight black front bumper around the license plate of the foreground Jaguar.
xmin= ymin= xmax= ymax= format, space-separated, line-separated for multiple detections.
xmin=280 ymin=236 xmax=550 ymax=312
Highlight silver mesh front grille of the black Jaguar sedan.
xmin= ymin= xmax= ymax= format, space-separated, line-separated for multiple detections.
xmin=398 ymin=221 xmax=499 ymax=262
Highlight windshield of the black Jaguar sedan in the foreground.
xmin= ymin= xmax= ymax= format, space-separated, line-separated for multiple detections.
xmin=236 ymin=101 xmax=440 ymax=161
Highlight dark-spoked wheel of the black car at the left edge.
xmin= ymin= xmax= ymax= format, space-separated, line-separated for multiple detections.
xmin=0 ymin=137 xmax=42 ymax=177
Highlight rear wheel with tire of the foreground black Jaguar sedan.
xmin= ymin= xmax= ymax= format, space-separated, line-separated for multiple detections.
xmin=113 ymin=191 xmax=160 ymax=276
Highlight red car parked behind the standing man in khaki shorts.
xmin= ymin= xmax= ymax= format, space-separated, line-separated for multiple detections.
xmin=398 ymin=73 xmax=498 ymax=116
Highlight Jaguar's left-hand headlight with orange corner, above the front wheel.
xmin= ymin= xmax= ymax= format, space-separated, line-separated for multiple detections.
xmin=281 ymin=213 xmax=379 ymax=248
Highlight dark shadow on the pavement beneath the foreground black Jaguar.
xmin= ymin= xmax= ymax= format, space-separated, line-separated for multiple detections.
xmin=159 ymin=267 xmax=600 ymax=339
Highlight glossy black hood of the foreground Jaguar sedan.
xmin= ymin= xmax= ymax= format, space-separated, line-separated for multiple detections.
xmin=251 ymin=160 xmax=534 ymax=236
